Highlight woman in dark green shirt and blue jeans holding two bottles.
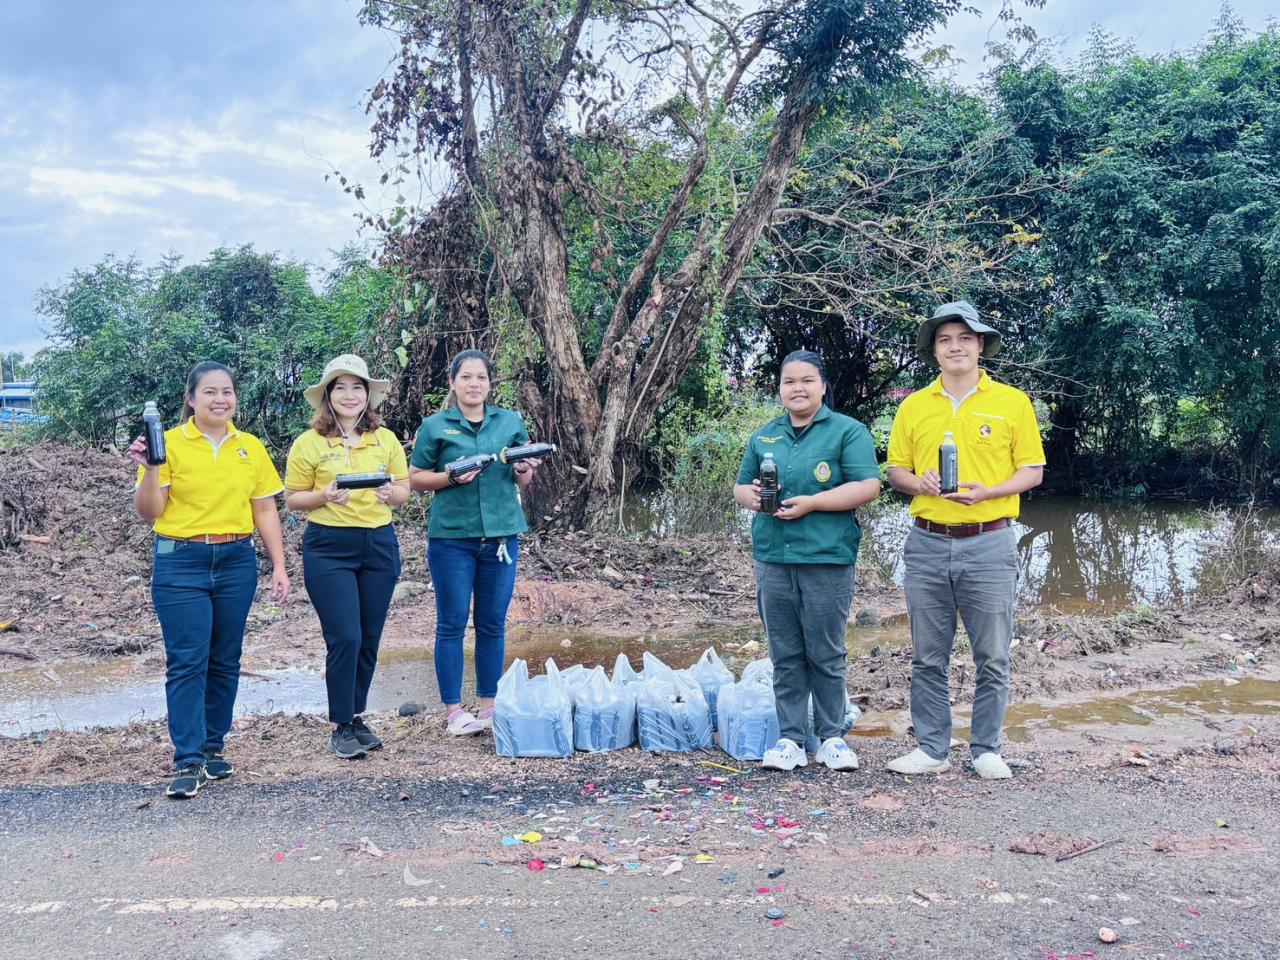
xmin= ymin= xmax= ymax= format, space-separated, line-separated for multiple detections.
xmin=408 ymin=349 xmax=538 ymax=736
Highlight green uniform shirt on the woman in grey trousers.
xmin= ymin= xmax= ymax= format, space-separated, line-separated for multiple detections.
xmin=737 ymin=406 xmax=879 ymax=563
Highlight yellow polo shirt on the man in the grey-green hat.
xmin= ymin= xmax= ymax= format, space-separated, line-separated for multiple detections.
xmin=886 ymin=370 xmax=1044 ymax=524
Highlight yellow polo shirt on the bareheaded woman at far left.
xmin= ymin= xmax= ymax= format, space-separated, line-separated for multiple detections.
xmin=137 ymin=417 xmax=284 ymax=538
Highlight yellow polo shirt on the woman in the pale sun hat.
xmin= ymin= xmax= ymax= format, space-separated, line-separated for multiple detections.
xmin=284 ymin=426 xmax=408 ymax=527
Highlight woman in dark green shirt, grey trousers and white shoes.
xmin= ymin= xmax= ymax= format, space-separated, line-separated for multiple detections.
xmin=733 ymin=351 xmax=879 ymax=771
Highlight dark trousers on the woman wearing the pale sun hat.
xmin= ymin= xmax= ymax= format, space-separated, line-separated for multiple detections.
xmin=302 ymin=524 xmax=401 ymax=723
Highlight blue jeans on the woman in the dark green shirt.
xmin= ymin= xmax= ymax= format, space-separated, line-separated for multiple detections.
xmin=426 ymin=536 xmax=520 ymax=704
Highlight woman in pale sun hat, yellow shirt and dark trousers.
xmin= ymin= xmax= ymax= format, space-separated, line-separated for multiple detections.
xmin=284 ymin=353 xmax=410 ymax=760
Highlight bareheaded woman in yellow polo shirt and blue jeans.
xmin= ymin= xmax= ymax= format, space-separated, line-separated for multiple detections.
xmin=128 ymin=362 xmax=289 ymax=797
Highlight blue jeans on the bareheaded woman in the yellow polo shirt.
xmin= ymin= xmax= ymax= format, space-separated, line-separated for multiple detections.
xmin=151 ymin=536 xmax=257 ymax=768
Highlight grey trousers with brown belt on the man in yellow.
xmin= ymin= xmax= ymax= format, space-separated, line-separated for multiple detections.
xmin=902 ymin=526 xmax=1018 ymax=760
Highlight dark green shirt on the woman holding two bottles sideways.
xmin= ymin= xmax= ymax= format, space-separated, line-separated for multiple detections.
xmin=410 ymin=404 xmax=529 ymax=539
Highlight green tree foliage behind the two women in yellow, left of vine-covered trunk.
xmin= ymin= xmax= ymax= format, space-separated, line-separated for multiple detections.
xmin=35 ymin=247 xmax=396 ymax=454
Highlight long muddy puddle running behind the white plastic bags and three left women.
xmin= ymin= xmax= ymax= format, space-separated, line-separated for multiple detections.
xmin=0 ymin=622 xmax=908 ymax=736
